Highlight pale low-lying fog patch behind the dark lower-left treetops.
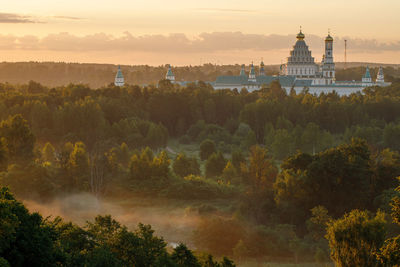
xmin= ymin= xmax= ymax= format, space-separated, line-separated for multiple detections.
xmin=24 ymin=193 xmax=200 ymax=246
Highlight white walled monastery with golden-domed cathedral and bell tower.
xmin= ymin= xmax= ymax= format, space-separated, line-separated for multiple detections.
xmin=213 ymin=30 xmax=390 ymax=95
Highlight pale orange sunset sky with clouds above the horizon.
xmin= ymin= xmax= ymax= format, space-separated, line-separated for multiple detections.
xmin=0 ymin=0 xmax=400 ymax=65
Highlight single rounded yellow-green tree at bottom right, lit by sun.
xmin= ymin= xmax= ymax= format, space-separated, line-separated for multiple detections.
xmin=326 ymin=210 xmax=386 ymax=267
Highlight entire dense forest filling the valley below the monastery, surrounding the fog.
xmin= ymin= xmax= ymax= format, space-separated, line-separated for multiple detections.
xmin=0 ymin=77 xmax=400 ymax=266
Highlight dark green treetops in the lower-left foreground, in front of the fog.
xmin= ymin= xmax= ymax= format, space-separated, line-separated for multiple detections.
xmin=0 ymin=187 xmax=235 ymax=267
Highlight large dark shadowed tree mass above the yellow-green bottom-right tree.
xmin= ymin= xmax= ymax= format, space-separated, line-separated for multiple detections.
xmin=274 ymin=140 xmax=379 ymax=219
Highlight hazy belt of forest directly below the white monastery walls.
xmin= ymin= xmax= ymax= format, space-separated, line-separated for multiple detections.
xmin=0 ymin=76 xmax=400 ymax=159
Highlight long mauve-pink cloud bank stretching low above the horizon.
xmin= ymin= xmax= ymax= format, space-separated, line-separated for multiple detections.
xmin=0 ymin=32 xmax=400 ymax=54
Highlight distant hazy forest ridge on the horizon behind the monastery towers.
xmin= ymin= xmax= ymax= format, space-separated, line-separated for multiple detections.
xmin=0 ymin=62 xmax=400 ymax=88
